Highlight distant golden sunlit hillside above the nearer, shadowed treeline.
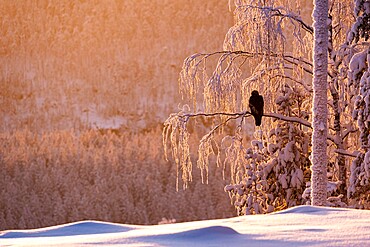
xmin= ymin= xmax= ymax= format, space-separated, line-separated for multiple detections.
xmin=0 ymin=0 xmax=232 ymax=132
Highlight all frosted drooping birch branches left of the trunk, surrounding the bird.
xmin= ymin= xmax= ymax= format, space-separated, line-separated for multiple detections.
xmin=163 ymin=1 xmax=312 ymax=187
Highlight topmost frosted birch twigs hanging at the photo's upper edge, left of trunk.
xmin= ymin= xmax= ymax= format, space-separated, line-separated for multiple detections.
xmin=224 ymin=0 xmax=313 ymax=52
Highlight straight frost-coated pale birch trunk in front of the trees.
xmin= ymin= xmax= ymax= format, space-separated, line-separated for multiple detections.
xmin=311 ymin=0 xmax=328 ymax=206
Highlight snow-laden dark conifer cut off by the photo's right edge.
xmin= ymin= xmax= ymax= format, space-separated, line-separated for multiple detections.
xmin=347 ymin=0 xmax=370 ymax=207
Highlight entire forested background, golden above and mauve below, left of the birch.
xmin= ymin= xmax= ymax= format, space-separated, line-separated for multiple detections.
xmin=0 ymin=0 xmax=240 ymax=230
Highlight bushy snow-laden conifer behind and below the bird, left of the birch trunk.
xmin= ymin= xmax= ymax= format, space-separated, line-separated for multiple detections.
xmin=225 ymin=85 xmax=310 ymax=215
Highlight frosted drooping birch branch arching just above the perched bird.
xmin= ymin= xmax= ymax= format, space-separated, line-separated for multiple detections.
xmin=179 ymin=50 xmax=312 ymax=112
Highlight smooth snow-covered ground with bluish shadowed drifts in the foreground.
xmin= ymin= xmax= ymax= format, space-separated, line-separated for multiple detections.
xmin=0 ymin=206 xmax=370 ymax=247
